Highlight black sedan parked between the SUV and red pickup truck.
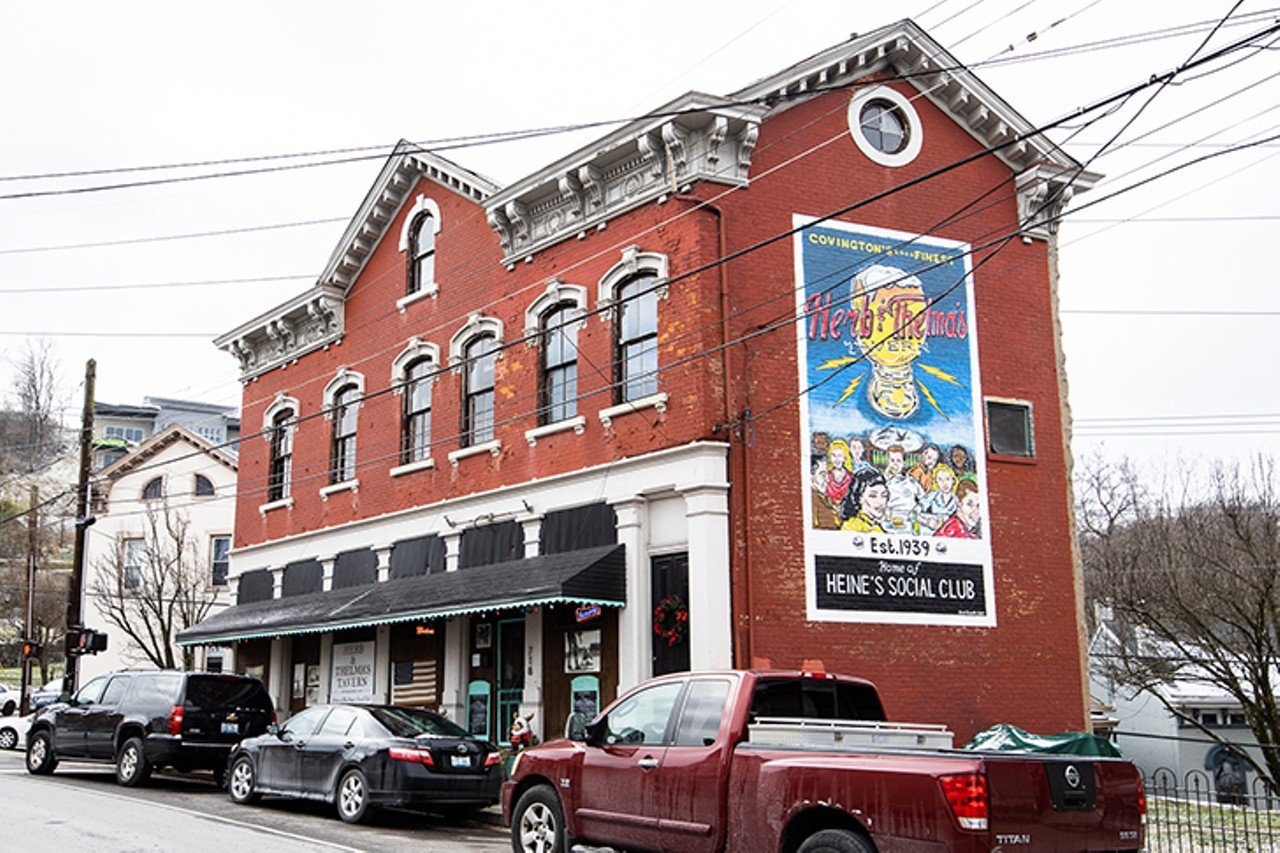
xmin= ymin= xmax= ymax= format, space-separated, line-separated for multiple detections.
xmin=227 ymin=704 xmax=502 ymax=824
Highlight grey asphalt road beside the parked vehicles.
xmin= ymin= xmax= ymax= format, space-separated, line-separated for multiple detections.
xmin=0 ymin=751 xmax=511 ymax=853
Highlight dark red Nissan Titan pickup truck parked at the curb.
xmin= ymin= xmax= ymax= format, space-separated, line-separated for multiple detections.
xmin=502 ymin=671 xmax=1146 ymax=853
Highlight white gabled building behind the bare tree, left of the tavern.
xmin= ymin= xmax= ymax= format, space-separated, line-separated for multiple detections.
xmin=79 ymin=424 xmax=236 ymax=684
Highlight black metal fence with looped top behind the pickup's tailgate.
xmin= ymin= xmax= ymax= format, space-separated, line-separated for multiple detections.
xmin=1143 ymin=768 xmax=1280 ymax=853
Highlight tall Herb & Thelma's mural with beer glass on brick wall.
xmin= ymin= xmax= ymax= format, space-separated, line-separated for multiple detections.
xmin=795 ymin=215 xmax=996 ymax=625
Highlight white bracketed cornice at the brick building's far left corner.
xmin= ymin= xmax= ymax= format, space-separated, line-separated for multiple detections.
xmin=214 ymin=284 xmax=344 ymax=382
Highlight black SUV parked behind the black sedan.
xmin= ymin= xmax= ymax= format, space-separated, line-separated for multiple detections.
xmin=27 ymin=670 xmax=275 ymax=786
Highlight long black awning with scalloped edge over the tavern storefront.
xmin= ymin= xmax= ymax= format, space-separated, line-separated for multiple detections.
xmin=178 ymin=544 xmax=626 ymax=646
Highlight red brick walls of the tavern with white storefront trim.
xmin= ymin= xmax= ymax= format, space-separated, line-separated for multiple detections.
xmin=199 ymin=18 xmax=1087 ymax=739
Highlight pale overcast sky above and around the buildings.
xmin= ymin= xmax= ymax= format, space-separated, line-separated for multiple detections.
xmin=0 ymin=0 xmax=1280 ymax=471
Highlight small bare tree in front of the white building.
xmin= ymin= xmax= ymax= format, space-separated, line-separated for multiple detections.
xmin=90 ymin=503 xmax=220 ymax=669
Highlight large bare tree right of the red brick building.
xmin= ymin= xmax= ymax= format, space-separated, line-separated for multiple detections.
xmin=1076 ymin=457 xmax=1280 ymax=793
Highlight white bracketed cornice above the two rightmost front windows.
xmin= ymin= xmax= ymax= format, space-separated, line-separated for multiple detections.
xmin=484 ymin=92 xmax=767 ymax=266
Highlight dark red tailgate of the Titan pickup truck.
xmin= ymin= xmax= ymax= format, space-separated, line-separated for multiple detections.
xmin=984 ymin=753 xmax=1143 ymax=850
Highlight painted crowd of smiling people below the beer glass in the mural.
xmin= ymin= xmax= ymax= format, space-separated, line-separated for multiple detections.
xmin=813 ymin=435 xmax=982 ymax=539
